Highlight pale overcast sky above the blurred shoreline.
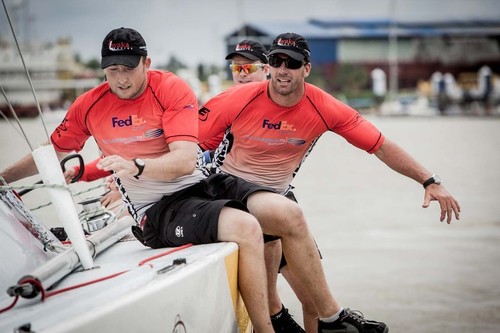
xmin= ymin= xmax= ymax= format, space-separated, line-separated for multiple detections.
xmin=0 ymin=0 xmax=500 ymax=67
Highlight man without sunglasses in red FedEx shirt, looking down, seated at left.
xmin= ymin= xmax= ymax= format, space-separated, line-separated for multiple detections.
xmin=1 ymin=28 xmax=308 ymax=333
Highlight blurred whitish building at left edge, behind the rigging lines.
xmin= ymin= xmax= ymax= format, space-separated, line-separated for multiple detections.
xmin=0 ymin=39 xmax=100 ymax=116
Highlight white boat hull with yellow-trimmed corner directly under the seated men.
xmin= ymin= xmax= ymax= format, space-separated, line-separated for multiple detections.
xmin=0 ymin=241 xmax=249 ymax=333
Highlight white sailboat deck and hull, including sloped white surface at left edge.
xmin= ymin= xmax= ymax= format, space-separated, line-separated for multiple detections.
xmin=0 ymin=189 xmax=251 ymax=333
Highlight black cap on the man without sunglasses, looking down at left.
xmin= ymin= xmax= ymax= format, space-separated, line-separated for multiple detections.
xmin=101 ymin=27 xmax=148 ymax=69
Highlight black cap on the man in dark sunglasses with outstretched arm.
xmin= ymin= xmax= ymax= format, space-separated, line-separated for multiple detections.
xmin=269 ymin=32 xmax=311 ymax=62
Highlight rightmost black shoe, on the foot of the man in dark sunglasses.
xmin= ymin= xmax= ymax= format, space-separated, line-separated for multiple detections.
xmin=318 ymin=308 xmax=389 ymax=333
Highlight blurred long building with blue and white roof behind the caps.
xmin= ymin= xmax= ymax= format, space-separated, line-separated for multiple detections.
xmin=226 ymin=19 xmax=500 ymax=88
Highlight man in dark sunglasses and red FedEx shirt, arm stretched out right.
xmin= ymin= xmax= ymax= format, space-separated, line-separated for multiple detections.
xmin=198 ymin=33 xmax=460 ymax=333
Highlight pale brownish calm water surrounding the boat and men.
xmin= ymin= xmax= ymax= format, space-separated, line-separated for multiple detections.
xmin=0 ymin=116 xmax=500 ymax=333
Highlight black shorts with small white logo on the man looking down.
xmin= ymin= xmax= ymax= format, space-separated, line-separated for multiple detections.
xmin=142 ymin=174 xmax=275 ymax=248
